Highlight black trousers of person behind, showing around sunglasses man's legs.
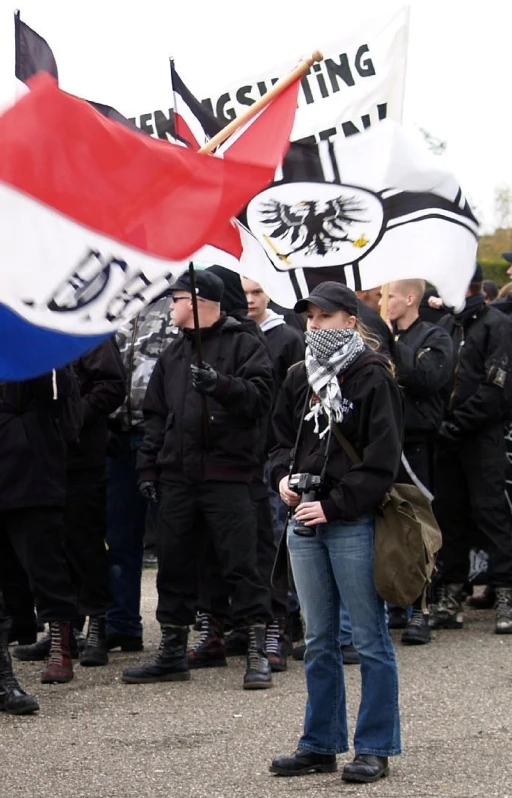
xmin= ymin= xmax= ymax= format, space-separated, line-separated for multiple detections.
xmin=197 ymin=483 xmax=288 ymax=619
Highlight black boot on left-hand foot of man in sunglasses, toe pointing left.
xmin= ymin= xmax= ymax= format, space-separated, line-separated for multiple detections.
xmin=122 ymin=626 xmax=190 ymax=684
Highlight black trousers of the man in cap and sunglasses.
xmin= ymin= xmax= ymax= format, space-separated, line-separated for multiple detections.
xmin=156 ymin=482 xmax=271 ymax=626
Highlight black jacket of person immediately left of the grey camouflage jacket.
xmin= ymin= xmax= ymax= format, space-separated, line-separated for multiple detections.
xmin=68 ymin=339 xmax=126 ymax=471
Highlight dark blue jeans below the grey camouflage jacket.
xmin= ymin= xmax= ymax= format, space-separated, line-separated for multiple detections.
xmin=107 ymin=432 xmax=147 ymax=636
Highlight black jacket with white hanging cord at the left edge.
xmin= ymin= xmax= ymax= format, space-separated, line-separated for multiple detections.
xmin=0 ymin=368 xmax=75 ymax=510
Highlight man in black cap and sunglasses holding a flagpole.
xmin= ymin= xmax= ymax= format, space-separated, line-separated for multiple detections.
xmin=123 ymin=271 xmax=273 ymax=689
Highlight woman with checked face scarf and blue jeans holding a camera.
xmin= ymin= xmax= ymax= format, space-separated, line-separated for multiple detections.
xmin=271 ymin=282 xmax=402 ymax=782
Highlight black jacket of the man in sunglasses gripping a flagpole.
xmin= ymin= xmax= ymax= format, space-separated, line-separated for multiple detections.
xmin=137 ymin=315 xmax=273 ymax=483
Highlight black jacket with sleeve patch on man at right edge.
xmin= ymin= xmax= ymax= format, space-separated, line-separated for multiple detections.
xmin=441 ymin=296 xmax=512 ymax=433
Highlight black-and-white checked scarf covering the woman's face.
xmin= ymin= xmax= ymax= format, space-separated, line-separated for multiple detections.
xmin=305 ymin=327 xmax=365 ymax=437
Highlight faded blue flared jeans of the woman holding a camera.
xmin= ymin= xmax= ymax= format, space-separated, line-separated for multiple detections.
xmin=288 ymin=518 xmax=401 ymax=756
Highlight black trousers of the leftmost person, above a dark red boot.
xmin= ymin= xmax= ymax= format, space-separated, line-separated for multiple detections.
xmin=0 ymin=507 xmax=78 ymax=623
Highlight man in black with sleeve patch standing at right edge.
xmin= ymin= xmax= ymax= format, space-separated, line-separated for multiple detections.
xmin=431 ymin=265 xmax=512 ymax=634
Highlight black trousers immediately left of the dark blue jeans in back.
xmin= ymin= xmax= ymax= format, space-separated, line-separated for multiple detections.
xmin=64 ymin=469 xmax=111 ymax=615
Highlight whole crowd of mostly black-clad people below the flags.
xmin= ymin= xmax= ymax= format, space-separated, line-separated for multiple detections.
xmin=0 ymin=262 xmax=512 ymax=782
